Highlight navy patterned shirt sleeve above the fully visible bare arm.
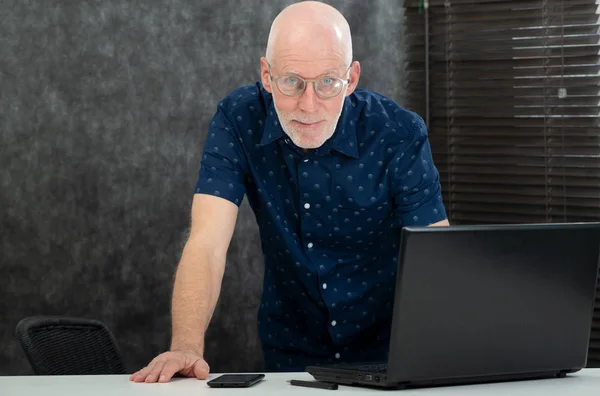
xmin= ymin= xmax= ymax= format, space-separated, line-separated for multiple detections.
xmin=196 ymin=106 xmax=247 ymax=206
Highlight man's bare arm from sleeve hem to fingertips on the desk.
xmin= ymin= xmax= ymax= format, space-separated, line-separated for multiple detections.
xmin=130 ymin=194 xmax=238 ymax=382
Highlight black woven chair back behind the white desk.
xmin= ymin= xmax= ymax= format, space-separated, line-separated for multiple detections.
xmin=16 ymin=316 xmax=126 ymax=375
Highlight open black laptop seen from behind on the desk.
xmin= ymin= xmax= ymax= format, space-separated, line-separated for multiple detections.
xmin=306 ymin=223 xmax=600 ymax=389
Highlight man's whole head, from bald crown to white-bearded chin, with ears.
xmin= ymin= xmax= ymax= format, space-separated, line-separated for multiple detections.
xmin=260 ymin=1 xmax=360 ymax=150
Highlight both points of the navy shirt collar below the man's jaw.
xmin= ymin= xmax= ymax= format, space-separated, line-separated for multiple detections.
xmin=259 ymin=88 xmax=358 ymax=158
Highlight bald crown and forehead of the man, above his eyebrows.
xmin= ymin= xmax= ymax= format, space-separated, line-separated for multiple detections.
xmin=266 ymin=1 xmax=352 ymax=67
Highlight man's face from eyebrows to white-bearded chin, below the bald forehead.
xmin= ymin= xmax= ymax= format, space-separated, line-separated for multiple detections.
xmin=263 ymin=59 xmax=355 ymax=149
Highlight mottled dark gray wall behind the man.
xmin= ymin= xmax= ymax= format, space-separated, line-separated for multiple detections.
xmin=0 ymin=0 xmax=403 ymax=375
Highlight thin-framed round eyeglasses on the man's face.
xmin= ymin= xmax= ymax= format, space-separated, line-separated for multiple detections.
xmin=269 ymin=65 xmax=350 ymax=99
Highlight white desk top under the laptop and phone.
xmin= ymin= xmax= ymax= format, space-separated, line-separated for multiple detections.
xmin=0 ymin=369 xmax=600 ymax=396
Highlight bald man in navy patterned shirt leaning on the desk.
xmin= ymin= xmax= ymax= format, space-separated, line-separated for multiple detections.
xmin=131 ymin=1 xmax=448 ymax=382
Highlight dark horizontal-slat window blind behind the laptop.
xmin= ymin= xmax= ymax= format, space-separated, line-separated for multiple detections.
xmin=404 ymin=0 xmax=600 ymax=367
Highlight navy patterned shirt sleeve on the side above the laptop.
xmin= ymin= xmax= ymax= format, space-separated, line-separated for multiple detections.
xmin=389 ymin=115 xmax=447 ymax=226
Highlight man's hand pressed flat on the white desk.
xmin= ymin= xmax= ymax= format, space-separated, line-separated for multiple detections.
xmin=129 ymin=350 xmax=210 ymax=382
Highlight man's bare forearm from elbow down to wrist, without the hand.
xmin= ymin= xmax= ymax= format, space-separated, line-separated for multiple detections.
xmin=171 ymin=238 xmax=225 ymax=354
